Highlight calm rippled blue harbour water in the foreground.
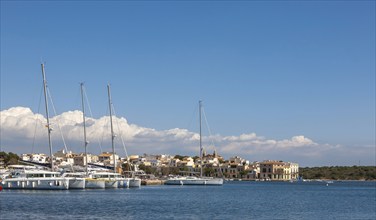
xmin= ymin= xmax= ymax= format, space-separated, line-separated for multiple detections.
xmin=0 ymin=182 xmax=376 ymax=220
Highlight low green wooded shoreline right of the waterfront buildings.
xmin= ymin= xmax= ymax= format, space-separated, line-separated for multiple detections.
xmin=299 ymin=166 xmax=376 ymax=180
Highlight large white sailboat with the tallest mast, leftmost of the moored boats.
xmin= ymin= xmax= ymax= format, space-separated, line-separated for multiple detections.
xmin=0 ymin=64 xmax=69 ymax=190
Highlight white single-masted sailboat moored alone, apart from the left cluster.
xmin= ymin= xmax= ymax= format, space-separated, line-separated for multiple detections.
xmin=165 ymin=101 xmax=223 ymax=185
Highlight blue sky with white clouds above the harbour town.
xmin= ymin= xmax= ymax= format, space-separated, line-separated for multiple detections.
xmin=0 ymin=0 xmax=376 ymax=166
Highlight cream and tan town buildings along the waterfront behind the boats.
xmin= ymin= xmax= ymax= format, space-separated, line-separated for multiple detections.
xmin=0 ymin=150 xmax=299 ymax=181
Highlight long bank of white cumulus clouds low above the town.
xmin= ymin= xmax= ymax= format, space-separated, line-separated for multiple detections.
xmin=0 ymin=107 xmax=374 ymax=165
